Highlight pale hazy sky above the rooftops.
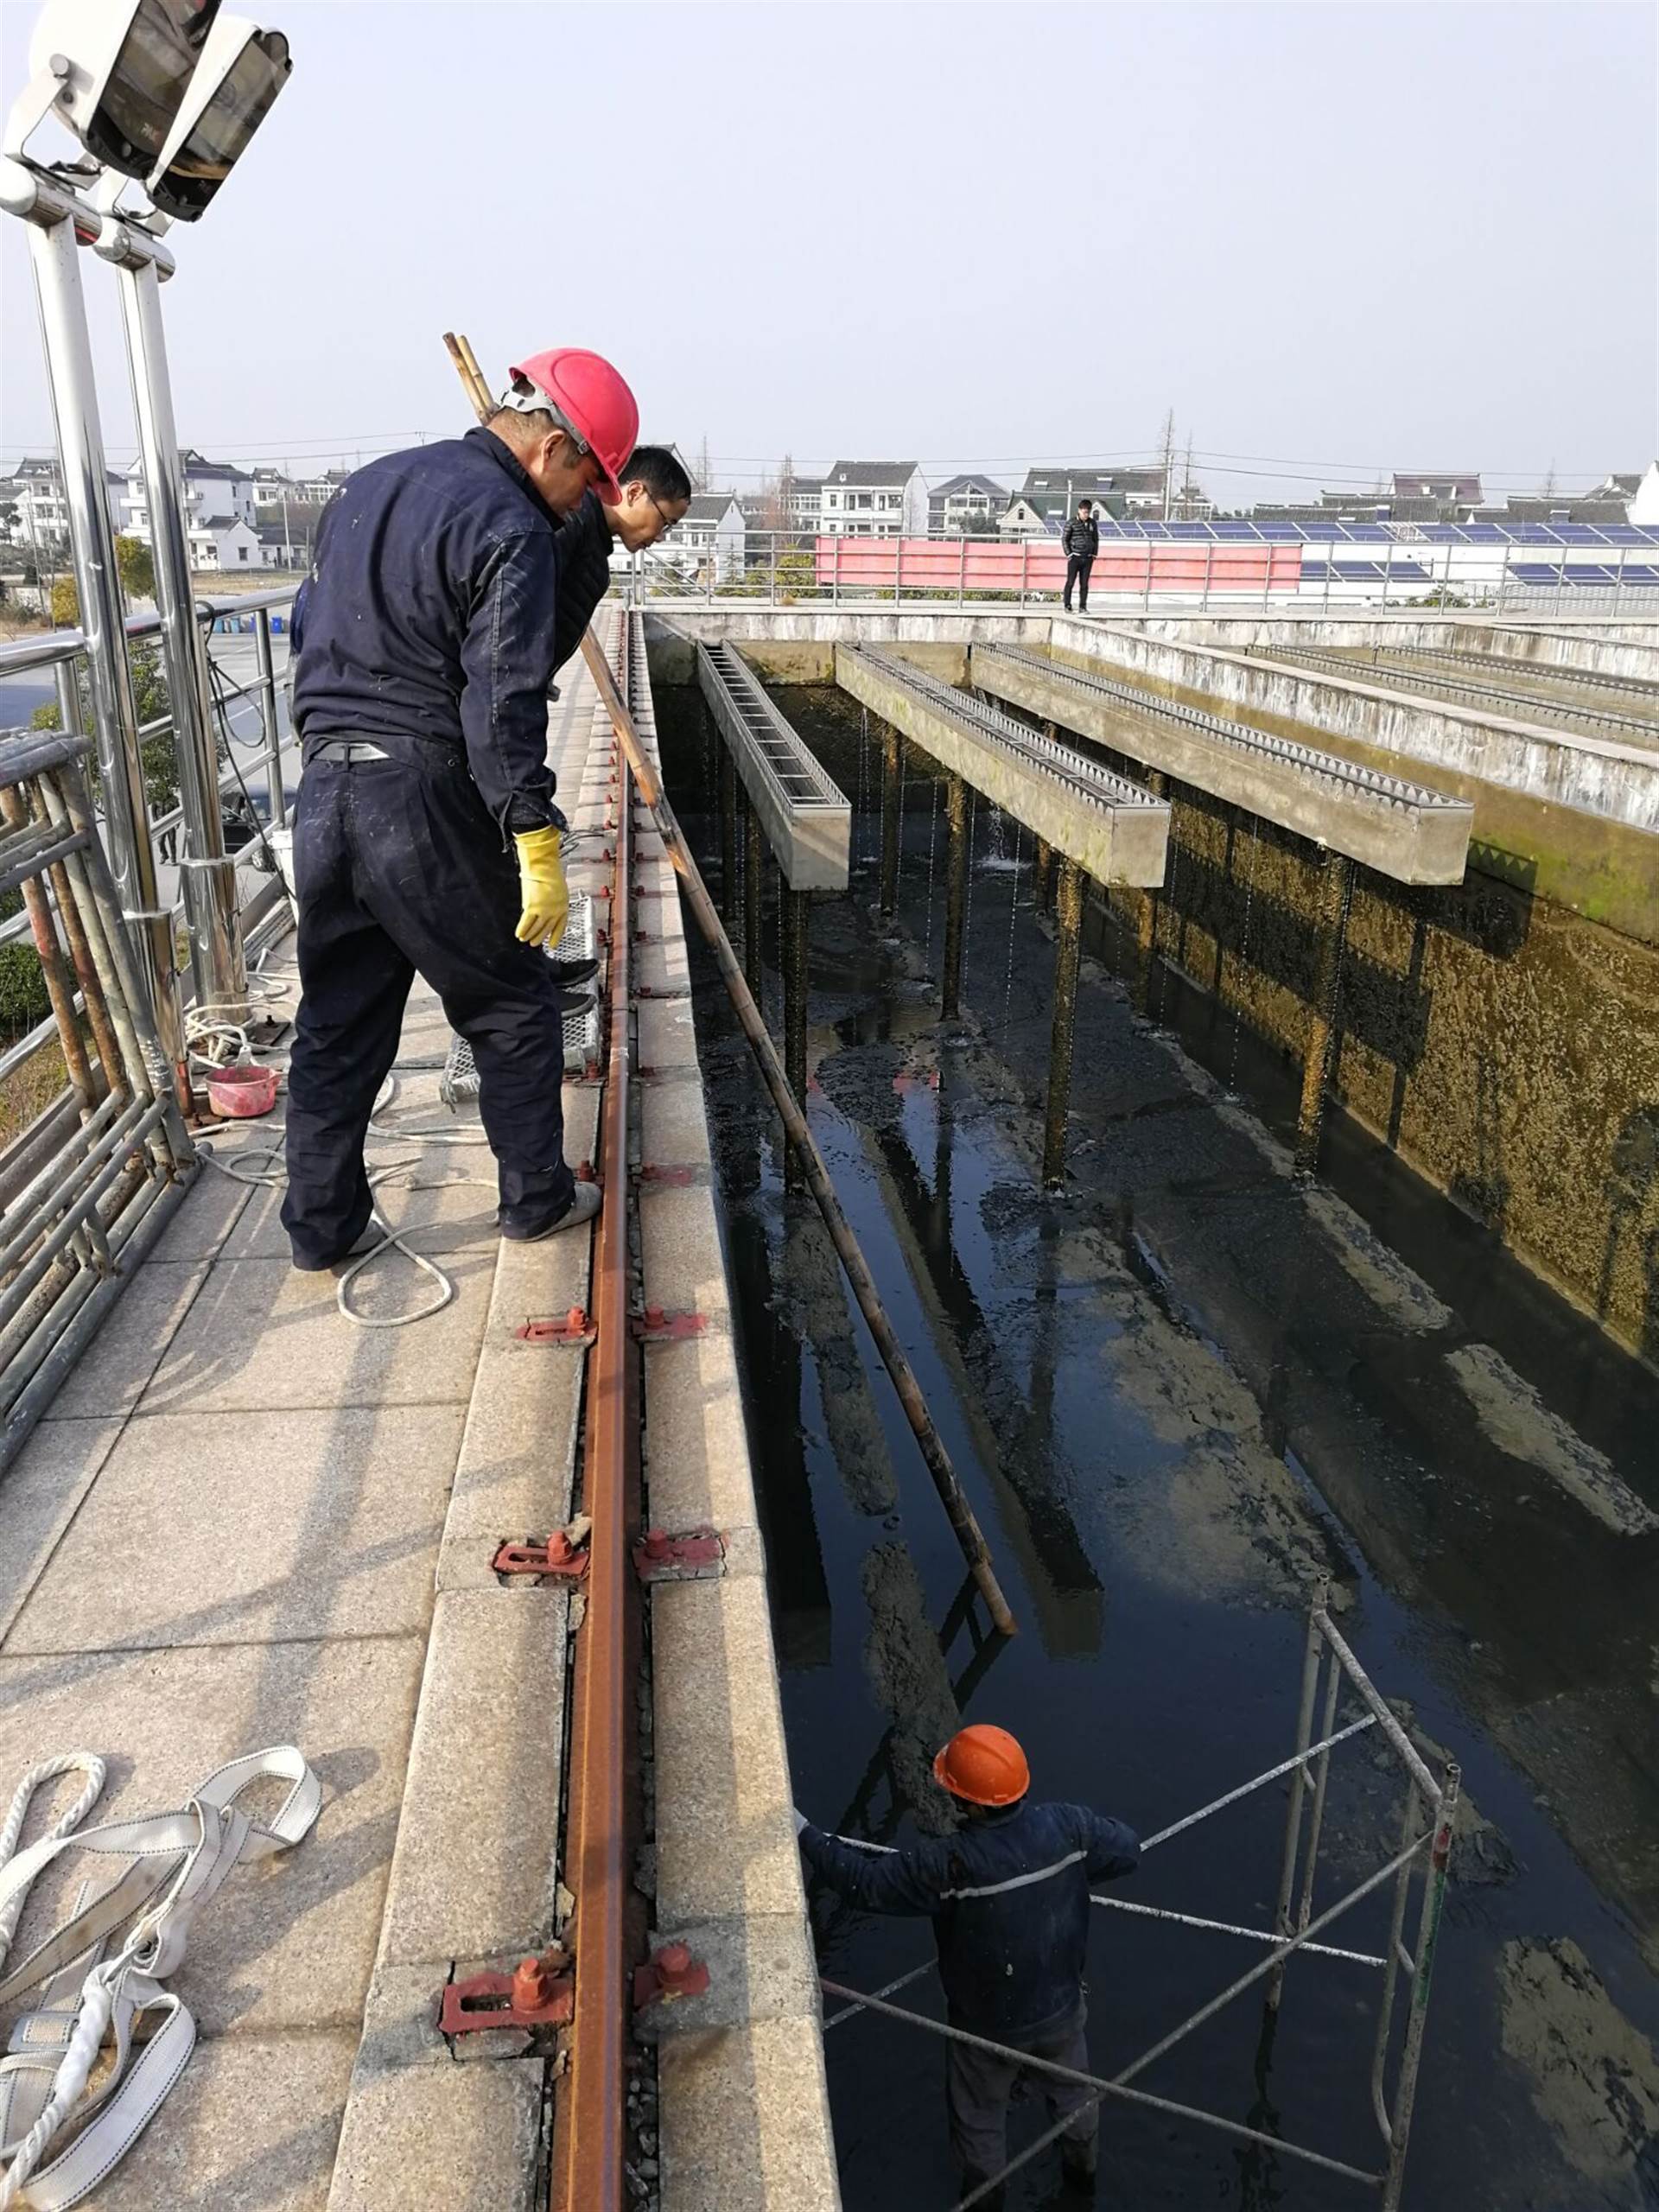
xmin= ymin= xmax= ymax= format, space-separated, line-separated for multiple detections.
xmin=0 ymin=0 xmax=1659 ymax=505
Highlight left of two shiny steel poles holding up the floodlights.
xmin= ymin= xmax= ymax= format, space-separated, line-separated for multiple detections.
xmin=29 ymin=213 xmax=190 ymax=1103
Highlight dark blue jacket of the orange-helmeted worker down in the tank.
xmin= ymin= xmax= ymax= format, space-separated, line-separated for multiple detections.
xmin=801 ymin=1798 xmax=1141 ymax=2037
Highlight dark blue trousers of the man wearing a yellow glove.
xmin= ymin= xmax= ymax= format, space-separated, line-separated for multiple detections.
xmin=283 ymin=754 xmax=575 ymax=1268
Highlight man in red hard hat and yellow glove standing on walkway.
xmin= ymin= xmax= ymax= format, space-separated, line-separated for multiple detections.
xmin=283 ymin=345 xmax=639 ymax=1269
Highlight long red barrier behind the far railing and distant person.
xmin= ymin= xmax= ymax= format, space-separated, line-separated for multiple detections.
xmin=817 ymin=537 xmax=1303 ymax=600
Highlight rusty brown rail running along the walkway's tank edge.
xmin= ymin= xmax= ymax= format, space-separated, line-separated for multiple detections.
xmin=553 ymin=615 xmax=639 ymax=2212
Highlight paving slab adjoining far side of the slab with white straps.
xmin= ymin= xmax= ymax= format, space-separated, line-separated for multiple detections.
xmin=7 ymin=1407 xmax=462 ymax=1652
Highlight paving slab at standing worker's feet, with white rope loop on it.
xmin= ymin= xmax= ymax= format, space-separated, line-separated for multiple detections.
xmin=142 ymin=1249 xmax=495 ymax=1414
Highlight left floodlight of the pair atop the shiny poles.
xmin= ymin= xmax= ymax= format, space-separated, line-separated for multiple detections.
xmin=24 ymin=0 xmax=219 ymax=177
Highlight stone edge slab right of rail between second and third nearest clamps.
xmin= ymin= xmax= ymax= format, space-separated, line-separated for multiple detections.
xmin=646 ymin=1336 xmax=754 ymax=1529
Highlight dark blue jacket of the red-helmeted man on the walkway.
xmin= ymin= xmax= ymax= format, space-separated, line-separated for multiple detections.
xmin=294 ymin=429 xmax=562 ymax=830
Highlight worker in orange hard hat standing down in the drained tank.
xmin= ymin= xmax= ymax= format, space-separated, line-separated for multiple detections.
xmin=794 ymin=1723 xmax=1141 ymax=2208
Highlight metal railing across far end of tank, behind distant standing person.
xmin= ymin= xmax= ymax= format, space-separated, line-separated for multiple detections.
xmin=628 ymin=531 xmax=1659 ymax=617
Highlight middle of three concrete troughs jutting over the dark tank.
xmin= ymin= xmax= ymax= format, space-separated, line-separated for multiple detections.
xmin=836 ymin=646 xmax=1170 ymax=887
